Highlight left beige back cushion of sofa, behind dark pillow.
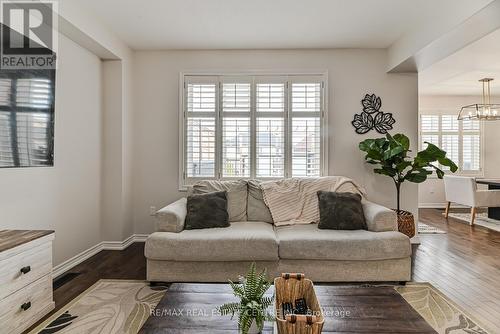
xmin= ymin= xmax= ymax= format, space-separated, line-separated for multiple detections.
xmin=192 ymin=180 xmax=248 ymax=222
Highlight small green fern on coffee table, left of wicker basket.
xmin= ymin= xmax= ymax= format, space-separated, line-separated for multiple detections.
xmin=219 ymin=262 xmax=274 ymax=334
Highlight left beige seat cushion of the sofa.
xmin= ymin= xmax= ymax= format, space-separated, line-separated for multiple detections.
xmin=145 ymin=222 xmax=278 ymax=262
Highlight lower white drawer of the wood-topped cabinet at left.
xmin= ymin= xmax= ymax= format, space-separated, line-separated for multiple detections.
xmin=0 ymin=275 xmax=54 ymax=334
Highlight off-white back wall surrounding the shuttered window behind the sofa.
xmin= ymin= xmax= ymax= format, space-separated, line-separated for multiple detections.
xmin=132 ymin=50 xmax=418 ymax=233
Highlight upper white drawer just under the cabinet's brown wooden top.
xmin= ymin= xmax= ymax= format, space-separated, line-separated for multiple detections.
xmin=0 ymin=241 xmax=52 ymax=300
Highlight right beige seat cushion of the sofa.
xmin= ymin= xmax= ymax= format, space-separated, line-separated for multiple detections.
xmin=276 ymin=224 xmax=411 ymax=261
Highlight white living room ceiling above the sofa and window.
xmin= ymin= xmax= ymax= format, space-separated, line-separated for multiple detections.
xmin=71 ymin=0 xmax=491 ymax=50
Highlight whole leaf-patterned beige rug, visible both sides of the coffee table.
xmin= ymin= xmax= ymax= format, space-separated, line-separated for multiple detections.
xmin=29 ymin=280 xmax=487 ymax=334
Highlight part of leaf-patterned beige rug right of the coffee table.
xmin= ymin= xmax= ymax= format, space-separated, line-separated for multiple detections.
xmin=395 ymin=283 xmax=488 ymax=334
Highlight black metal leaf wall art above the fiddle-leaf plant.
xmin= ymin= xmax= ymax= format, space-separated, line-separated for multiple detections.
xmin=351 ymin=94 xmax=396 ymax=134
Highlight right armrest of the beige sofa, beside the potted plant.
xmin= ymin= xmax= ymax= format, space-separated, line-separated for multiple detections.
xmin=362 ymin=200 xmax=398 ymax=232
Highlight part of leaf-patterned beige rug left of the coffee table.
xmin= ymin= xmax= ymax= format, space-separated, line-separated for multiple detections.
xmin=30 ymin=280 xmax=166 ymax=334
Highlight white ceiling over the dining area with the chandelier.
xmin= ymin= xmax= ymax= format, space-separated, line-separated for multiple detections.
xmin=419 ymin=30 xmax=500 ymax=96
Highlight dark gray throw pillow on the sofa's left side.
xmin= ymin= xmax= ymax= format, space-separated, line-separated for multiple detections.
xmin=184 ymin=191 xmax=229 ymax=230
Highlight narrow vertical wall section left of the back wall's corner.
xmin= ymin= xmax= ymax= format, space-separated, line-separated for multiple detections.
xmin=101 ymin=60 xmax=133 ymax=241
